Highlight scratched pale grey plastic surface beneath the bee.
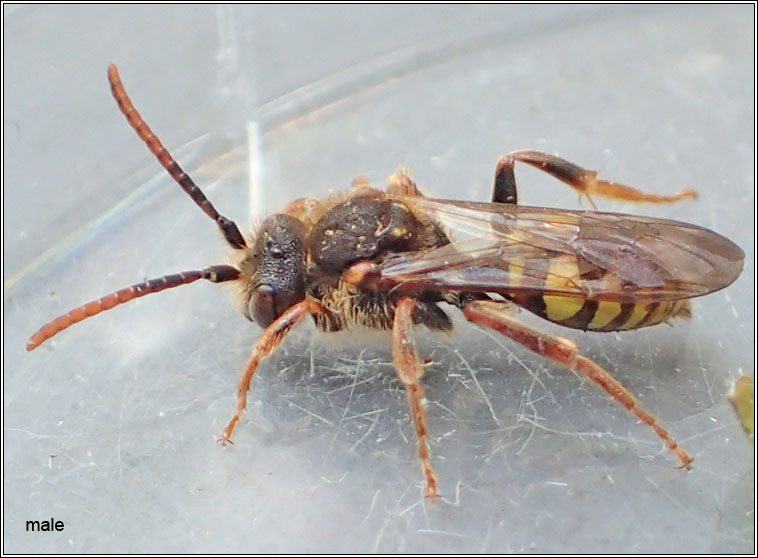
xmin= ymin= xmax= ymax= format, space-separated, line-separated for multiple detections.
xmin=3 ymin=6 xmax=755 ymax=553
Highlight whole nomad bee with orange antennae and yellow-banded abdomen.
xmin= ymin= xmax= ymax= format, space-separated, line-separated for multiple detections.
xmin=26 ymin=64 xmax=744 ymax=497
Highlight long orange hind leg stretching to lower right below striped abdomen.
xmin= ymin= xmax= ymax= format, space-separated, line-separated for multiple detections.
xmin=463 ymin=301 xmax=692 ymax=469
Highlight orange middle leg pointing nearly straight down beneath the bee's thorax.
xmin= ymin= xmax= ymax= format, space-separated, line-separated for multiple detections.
xmin=392 ymin=297 xmax=437 ymax=498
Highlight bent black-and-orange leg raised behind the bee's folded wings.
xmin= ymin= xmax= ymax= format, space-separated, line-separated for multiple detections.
xmin=492 ymin=151 xmax=697 ymax=209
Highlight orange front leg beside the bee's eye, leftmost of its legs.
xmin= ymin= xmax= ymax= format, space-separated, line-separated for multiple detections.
xmin=219 ymin=299 xmax=326 ymax=444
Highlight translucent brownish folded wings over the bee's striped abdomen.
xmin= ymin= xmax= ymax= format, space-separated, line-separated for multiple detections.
xmin=376 ymin=197 xmax=744 ymax=302
